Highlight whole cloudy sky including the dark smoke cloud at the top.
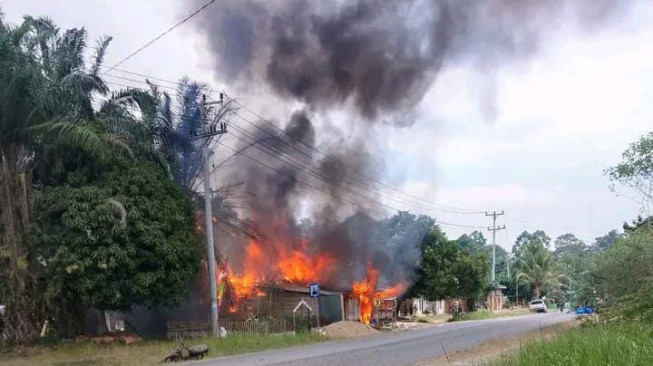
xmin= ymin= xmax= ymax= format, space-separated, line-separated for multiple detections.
xmin=7 ymin=0 xmax=653 ymax=252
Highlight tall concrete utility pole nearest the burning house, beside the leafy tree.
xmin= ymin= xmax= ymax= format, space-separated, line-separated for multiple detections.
xmin=193 ymin=95 xmax=227 ymax=337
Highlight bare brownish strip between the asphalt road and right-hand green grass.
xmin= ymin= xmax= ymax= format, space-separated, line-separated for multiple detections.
xmin=415 ymin=321 xmax=579 ymax=366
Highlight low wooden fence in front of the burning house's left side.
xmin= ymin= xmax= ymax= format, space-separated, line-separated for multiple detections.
xmin=167 ymin=319 xmax=294 ymax=339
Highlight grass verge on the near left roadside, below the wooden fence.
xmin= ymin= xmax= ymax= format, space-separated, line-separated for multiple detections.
xmin=0 ymin=333 xmax=328 ymax=366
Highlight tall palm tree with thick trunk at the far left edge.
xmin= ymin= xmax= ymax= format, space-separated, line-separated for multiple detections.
xmin=0 ymin=15 xmax=126 ymax=341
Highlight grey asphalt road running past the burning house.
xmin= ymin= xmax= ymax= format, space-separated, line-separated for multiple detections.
xmin=190 ymin=313 xmax=574 ymax=366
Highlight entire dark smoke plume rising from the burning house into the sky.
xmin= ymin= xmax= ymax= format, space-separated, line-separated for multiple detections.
xmin=183 ymin=0 xmax=626 ymax=286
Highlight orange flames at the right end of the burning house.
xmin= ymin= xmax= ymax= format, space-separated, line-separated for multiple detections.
xmin=351 ymin=264 xmax=407 ymax=324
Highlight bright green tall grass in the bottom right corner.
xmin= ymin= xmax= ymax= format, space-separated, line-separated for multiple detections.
xmin=484 ymin=322 xmax=653 ymax=366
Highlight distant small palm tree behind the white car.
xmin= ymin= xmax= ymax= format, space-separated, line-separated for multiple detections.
xmin=517 ymin=242 xmax=566 ymax=298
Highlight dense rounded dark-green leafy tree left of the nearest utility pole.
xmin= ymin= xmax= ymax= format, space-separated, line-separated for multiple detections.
xmin=35 ymin=158 xmax=199 ymax=334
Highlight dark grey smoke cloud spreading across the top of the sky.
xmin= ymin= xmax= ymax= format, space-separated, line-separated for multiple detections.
xmin=194 ymin=0 xmax=630 ymax=123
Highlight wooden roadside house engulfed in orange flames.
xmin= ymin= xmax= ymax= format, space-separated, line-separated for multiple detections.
xmin=217 ymin=240 xmax=407 ymax=324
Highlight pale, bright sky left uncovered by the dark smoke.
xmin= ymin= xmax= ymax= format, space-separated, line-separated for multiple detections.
xmin=2 ymin=0 xmax=653 ymax=248
